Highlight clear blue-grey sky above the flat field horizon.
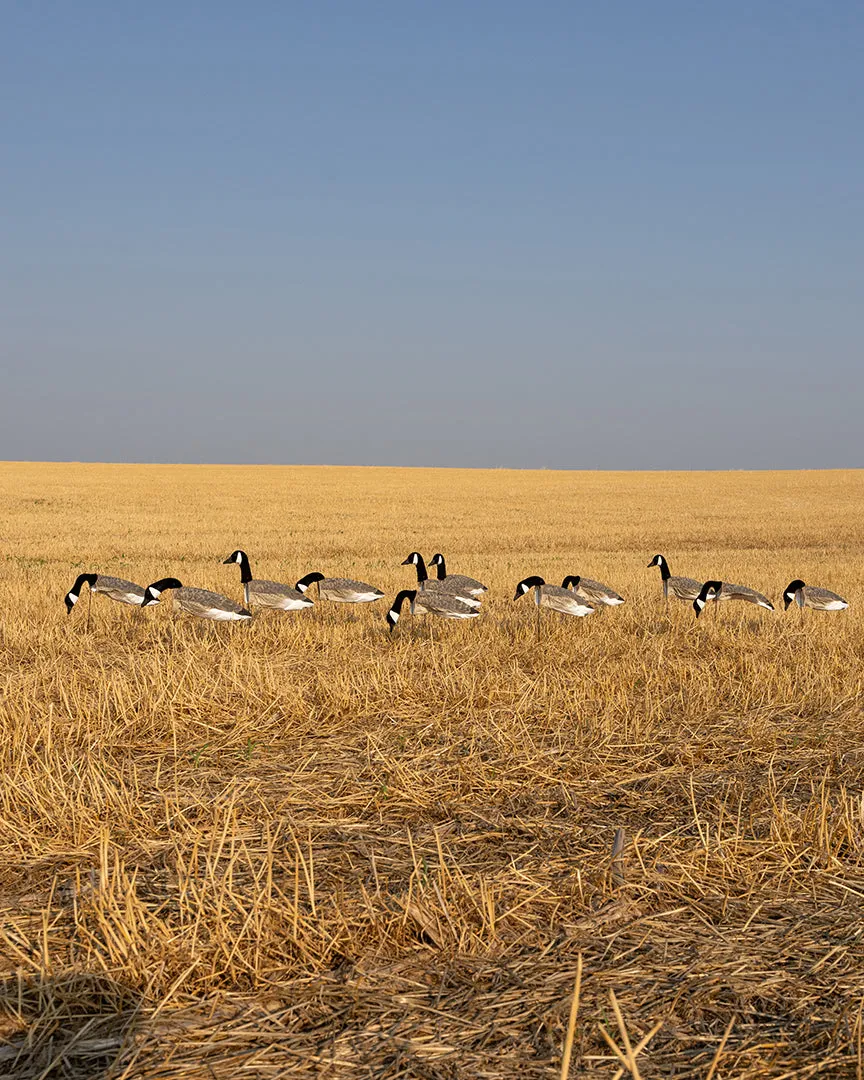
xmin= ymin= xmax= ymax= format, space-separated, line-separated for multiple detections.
xmin=0 ymin=0 xmax=864 ymax=469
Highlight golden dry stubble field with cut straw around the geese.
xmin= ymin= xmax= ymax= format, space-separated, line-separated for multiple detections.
xmin=0 ymin=464 xmax=864 ymax=1080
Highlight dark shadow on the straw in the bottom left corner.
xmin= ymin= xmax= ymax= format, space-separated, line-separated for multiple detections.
xmin=0 ymin=974 xmax=139 ymax=1080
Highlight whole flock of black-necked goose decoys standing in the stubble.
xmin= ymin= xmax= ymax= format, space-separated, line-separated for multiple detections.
xmin=65 ymin=549 xmax=849 ymax=638
